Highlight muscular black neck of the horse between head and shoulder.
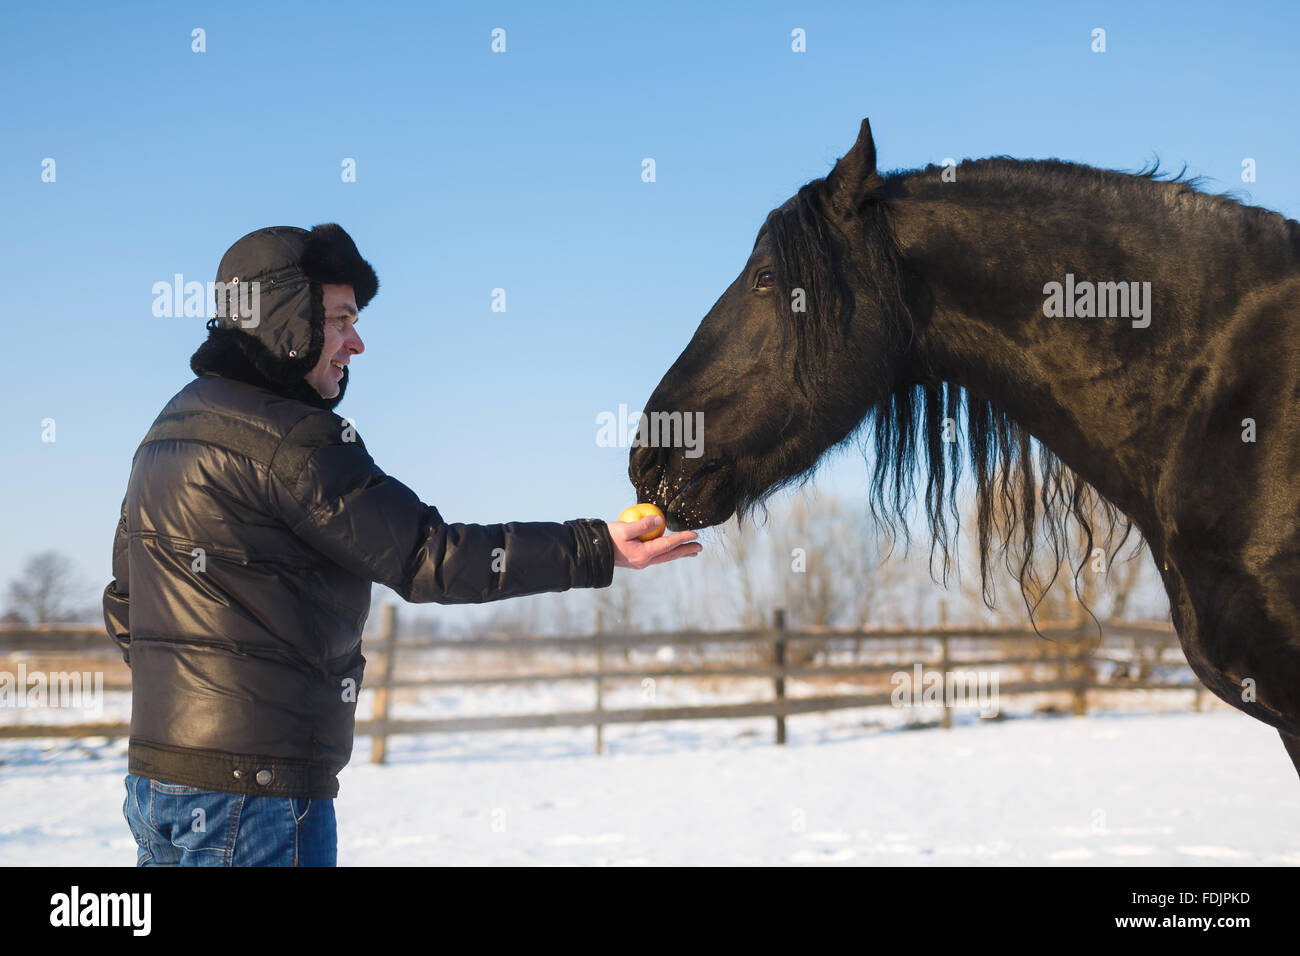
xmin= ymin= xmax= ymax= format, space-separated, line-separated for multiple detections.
xmin=891 ymin=170 xmax=1284 ymax=535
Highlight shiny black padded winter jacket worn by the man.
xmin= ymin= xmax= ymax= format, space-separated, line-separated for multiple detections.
xmin=104 ymin=373 xmax=614 ymax=799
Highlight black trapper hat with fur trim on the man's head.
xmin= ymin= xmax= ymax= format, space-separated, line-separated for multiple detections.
xmin=190 ymin=222 xmax=380 ymax=408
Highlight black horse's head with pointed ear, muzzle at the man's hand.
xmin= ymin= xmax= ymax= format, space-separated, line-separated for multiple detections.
xmin=628 ymin=120 xmax=910 ymax=529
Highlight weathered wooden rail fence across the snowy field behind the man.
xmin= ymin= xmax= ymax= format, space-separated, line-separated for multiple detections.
xmin=0 ymin=605 xmax=1204 ymax=763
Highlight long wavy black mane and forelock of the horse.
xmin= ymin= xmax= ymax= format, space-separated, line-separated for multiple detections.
xmin=745 ymin=160 xmax=1159 ymax=620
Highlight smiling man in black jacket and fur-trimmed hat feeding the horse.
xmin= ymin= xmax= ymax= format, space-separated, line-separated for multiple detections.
xmin=104 ymin=224 xmax=701 ymax=866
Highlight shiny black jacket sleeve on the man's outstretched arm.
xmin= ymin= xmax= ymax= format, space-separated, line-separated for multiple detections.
xmin=268 ymin=412 xmax=614 ymax=604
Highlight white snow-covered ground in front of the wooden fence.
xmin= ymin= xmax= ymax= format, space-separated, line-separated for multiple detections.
xmin=0 ymin=710 xmax=1300 ymax=866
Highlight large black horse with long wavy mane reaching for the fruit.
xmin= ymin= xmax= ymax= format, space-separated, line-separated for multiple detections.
xmin=629 ymin=120 xmax=1300 ymax=770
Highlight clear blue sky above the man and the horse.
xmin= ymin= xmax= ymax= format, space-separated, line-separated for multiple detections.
xmin=0 ymin=1 xmax=1300 ymax=621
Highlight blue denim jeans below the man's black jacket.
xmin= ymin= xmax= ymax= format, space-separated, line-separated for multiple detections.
xmin=122 ymin=774 xmax=338 ymax=866
